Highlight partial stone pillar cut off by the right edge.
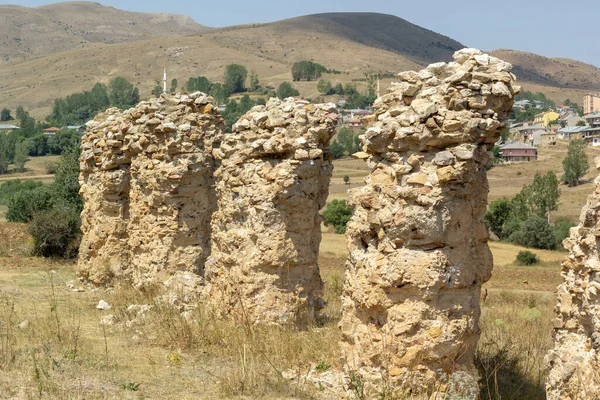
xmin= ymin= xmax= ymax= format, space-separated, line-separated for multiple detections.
xmin=546 ymin=158 xmax=600 ymax=400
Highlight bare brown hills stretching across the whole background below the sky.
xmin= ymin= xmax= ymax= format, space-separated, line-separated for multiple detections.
xmin=0 ymin=2 xmax=600 ymax=118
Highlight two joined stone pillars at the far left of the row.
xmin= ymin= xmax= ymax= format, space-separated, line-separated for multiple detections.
xmin=79 ymin=92 xmax=223 ymax=285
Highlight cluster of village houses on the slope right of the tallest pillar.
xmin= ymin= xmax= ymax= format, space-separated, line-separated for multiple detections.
xmin=497 ymin=94 xmax=600 ymax=162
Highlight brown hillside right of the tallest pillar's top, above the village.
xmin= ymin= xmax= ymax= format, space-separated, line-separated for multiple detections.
xmin=492 ymin=49 xmax=600 ymax=92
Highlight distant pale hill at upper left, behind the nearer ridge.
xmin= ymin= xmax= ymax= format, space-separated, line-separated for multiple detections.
xmin=0 ymin=2 xmax=209 ymax=65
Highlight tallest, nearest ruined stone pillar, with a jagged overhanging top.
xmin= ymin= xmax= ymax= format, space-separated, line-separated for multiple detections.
xmin=340 ymin=49 xmax=519 ymax=399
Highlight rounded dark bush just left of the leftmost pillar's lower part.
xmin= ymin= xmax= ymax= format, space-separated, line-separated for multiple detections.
xmin=29 ymin=207 xmax=81 ymax=258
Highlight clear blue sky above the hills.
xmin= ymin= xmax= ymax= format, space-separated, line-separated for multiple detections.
xmin=8 ymin=0 xmax=600 ymax=67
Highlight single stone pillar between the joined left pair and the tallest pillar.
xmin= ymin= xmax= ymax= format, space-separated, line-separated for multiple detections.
xmin=206 ymin=98 xmax=338 ymax=323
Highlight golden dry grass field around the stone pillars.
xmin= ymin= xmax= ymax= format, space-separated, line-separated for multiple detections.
xmin=0 ymin=139 xmax=600 ymax=400
